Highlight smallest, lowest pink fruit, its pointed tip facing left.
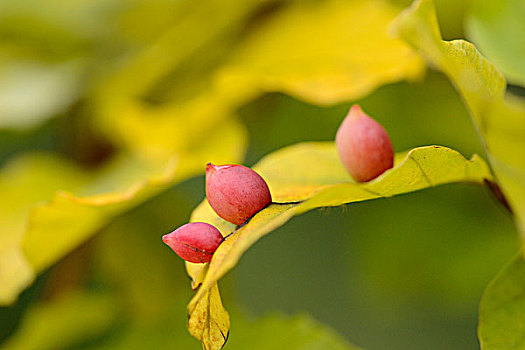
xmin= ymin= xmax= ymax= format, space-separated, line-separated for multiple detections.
xmin=162 ymin=222 xmax=223 ymax=263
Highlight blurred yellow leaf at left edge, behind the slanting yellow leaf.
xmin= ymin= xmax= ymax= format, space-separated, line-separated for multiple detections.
xmin=0 ymin=154 xmax=87 ymax=304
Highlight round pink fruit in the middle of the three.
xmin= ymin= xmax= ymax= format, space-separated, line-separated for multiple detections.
xmin=206 ymin=163 xmax=272 ymax=225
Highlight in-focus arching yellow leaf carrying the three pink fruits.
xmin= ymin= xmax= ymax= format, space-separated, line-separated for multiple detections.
xmin=187 ymin=142 xmax=492 ymax=348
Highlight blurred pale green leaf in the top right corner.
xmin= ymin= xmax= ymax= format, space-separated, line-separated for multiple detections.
xmin=466 ymin=0 xmax=525 ymax=86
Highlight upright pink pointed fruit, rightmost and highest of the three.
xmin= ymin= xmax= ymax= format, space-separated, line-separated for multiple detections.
xmin=335 ymin=105 xmax=394 ymax=182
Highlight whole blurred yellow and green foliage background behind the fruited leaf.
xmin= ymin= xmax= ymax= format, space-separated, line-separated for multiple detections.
xmin=0 ymin=0 xmax=525 ymax=349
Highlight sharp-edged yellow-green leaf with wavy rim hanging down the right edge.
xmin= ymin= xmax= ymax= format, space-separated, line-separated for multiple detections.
xmin=393 ymin=0 xmax=525 ymax=233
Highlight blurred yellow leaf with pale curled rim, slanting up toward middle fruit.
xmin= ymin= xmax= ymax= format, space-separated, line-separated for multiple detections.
xmin=23 ymin=116 xmax=245 ymax=271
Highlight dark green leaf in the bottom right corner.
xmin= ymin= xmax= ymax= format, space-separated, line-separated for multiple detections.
xmin=478 ymin=253 xmax=525 ymax=350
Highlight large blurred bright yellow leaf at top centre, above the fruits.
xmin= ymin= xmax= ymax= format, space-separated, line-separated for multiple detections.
xmin=222 ymin=0 xmax=424 ymax=104
